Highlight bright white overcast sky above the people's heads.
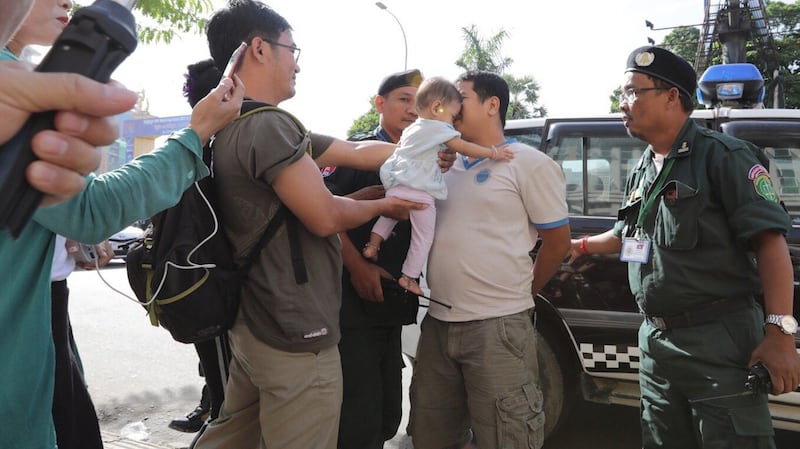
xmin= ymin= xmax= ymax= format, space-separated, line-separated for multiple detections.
xmin=114 ymin=0 xmax=716 ymax=137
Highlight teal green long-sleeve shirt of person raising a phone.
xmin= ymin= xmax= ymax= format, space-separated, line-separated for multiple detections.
xmin=0 ymin=124 xmax=208 ymax=449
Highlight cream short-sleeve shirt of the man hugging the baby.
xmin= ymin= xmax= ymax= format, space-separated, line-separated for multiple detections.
xmin=426 ymin=141 xmax=569 ymax=322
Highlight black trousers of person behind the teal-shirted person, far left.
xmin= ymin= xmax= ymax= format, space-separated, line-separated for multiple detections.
xmin=51 ymin=280 xmax=103 ymax=449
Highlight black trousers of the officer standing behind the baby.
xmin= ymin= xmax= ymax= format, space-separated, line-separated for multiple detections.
xmin=338 ymin=325 xmax=404 ymax=449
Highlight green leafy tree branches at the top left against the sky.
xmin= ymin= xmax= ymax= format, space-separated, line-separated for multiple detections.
xmin=75 ymin=0 xmax=213 ymax=44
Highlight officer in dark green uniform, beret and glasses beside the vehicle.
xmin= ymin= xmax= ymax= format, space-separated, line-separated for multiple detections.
xmin=571 ymin=47 xmax=800 ymax=449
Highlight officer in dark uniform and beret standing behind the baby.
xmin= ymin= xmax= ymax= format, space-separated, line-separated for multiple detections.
xmin=322 ymin=70 xmax=422 ymax=449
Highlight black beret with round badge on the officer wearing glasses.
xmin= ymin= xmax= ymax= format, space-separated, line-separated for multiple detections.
xmin=625 ymin=46 xmax=697 ymax=98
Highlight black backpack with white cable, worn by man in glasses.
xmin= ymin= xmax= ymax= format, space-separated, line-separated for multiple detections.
xmin=126 ymin=101 xmax=307 ymax=343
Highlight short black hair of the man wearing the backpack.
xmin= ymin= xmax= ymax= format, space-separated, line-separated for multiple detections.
xmin=206 ymin=0 xmax=292 ymax=70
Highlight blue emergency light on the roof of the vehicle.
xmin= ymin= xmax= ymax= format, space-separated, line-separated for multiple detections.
xmin=697 ymin=63 xmax=765 ymax=107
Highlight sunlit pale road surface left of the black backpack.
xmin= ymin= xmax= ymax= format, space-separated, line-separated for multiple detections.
xmin=67 ymin=261 xmax=203 ymax=448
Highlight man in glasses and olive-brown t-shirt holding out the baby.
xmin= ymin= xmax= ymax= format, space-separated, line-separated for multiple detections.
xmin=187 ymin=0 xmax=446 ymax=449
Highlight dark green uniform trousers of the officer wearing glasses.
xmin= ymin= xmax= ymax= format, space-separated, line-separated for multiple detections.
xmin=639 ymin=302 xmax=775 ymax=449
